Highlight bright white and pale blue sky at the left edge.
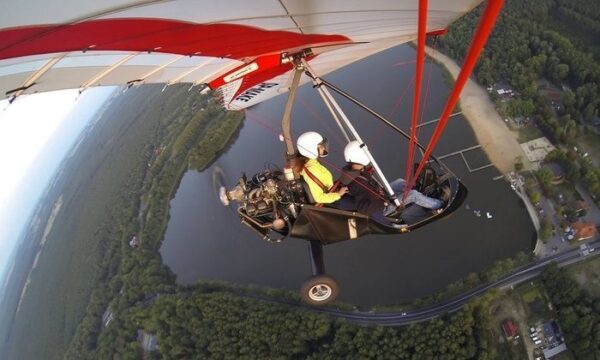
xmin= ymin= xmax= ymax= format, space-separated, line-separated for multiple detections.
xmin=0 ymin=87 xmax=115 ymax=282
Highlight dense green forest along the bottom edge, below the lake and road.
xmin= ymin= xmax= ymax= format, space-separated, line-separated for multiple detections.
xmin=112 ymin=291 xmax=496 ymax=359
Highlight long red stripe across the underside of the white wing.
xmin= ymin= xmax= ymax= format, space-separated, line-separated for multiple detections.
xmin=0 ymin=18 xmax=349 ymax=60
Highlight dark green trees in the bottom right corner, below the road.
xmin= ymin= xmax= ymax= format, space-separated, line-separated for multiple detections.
xmin=542 ymin=265 xmax=600 ymax=359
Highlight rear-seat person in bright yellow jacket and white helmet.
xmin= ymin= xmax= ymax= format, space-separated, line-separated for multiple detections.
xmin=296 ymin=131 xmax=354 ymax=210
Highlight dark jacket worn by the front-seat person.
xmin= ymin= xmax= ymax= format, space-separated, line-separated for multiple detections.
xmin=340 ymin=165 xmax=385 ymax=214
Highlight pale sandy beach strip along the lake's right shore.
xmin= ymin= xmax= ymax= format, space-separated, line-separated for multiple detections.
xmin=426 ymin=48 xmax=527 ymax=173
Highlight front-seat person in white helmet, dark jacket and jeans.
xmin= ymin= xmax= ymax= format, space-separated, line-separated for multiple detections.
xmin=341 ymin=141 xmax=443 ymax=226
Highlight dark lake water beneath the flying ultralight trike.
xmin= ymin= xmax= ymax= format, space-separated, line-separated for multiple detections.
xmin=160 ymin=46 xmax=535 ymax=306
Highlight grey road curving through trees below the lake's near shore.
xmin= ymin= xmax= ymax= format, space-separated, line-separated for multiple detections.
xmin=311 ymin=241 xmax=600 ymax=326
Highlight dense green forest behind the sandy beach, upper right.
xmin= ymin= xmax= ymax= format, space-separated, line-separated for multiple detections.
xmin=441 ymin=0 xmax=600 ymax=126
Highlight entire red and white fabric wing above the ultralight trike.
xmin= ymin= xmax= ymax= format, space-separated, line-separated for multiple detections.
xmin=0 ymin=0 xmax=482 ymax=109
